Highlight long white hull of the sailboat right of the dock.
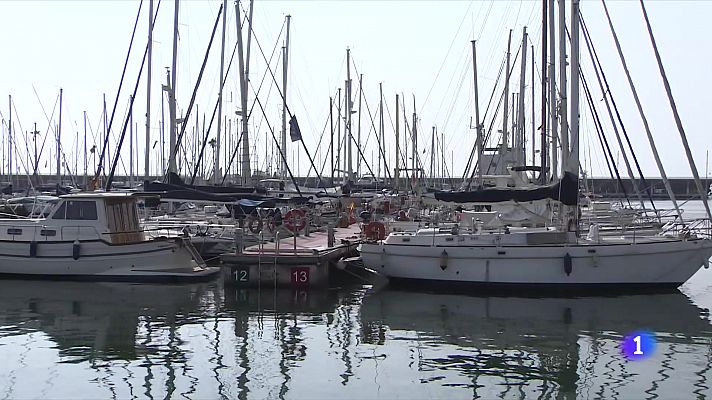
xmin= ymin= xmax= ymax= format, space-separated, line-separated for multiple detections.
xmin=359 ymin=239 xmax=712 ymax=286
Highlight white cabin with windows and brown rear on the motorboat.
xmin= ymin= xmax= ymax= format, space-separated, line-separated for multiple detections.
xmin=0 ymin=192 xmax=145 ymax=244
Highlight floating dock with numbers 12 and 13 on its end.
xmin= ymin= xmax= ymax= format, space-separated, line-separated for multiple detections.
xmin=220 ymin=224 xmax=361 ymax=288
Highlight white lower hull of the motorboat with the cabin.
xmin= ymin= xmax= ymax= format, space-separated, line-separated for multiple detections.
xmin=0 ymin=240 xmax=217 ymax=281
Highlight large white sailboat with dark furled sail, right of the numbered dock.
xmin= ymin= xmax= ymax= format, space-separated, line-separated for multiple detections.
xmin=359 ymin=0 xmax=712 ymax=289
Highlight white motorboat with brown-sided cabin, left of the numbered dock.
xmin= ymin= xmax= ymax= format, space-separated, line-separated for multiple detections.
xmin=0 ymin=192 xmax=218 ymax=281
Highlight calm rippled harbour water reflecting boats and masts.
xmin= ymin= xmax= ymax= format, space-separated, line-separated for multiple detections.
xmin=0 ymin=203 xmax=712 ymax=399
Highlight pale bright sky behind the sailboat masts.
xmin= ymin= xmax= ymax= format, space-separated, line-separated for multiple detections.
xmin=0 ymin=0 xmax=712 ymax=183
